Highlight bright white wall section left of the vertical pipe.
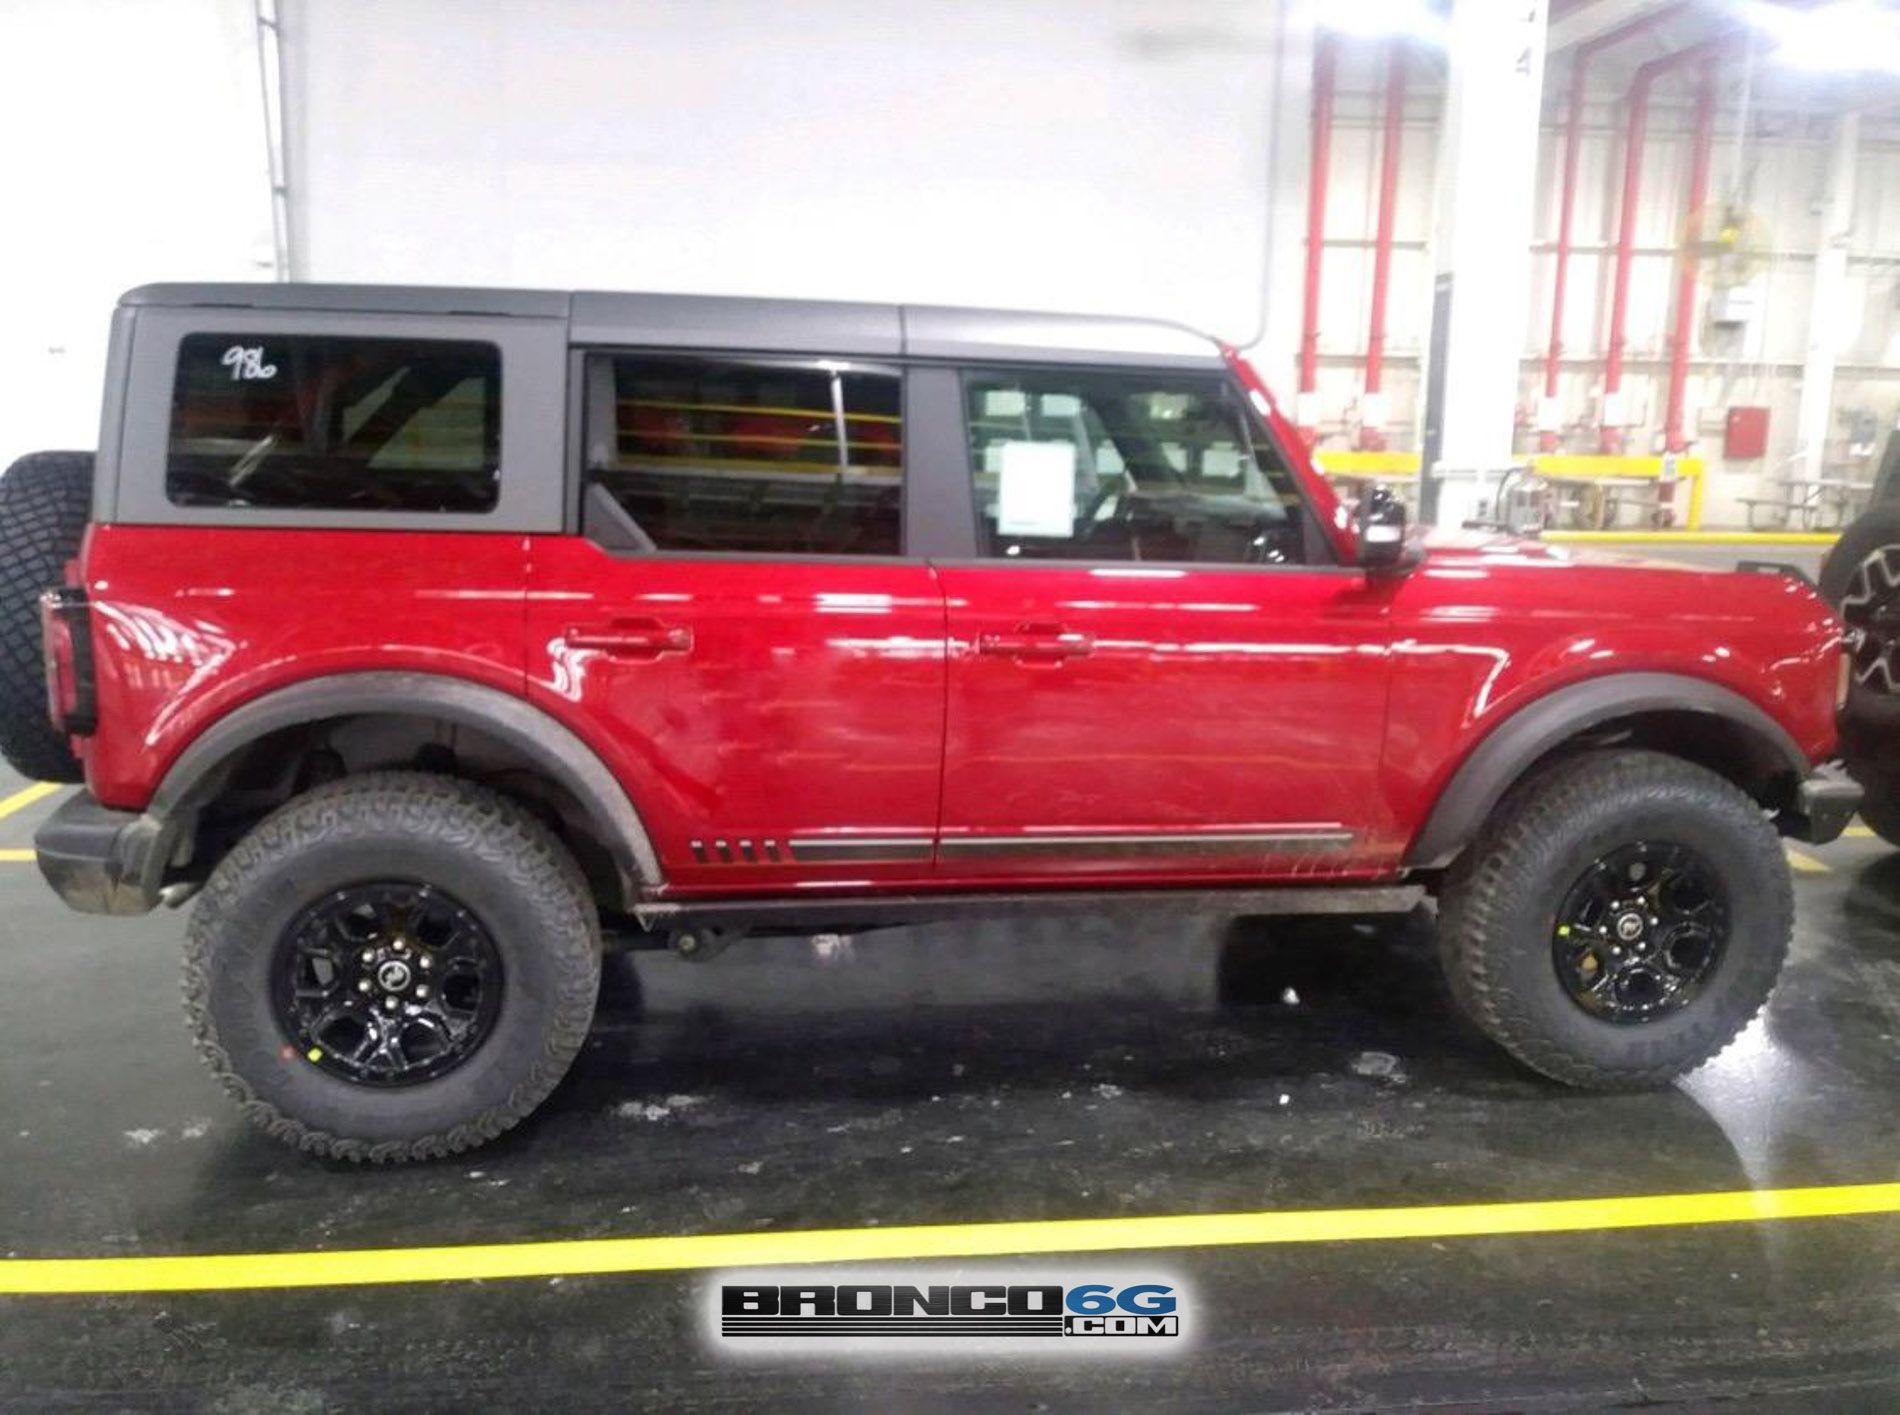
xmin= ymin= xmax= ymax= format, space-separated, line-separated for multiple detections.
xmin=0 ymin=0 xmax=272 ymax=467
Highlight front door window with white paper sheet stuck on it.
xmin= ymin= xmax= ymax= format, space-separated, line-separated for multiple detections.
xmin=963 ymin=370 xmax=1307 ymax=564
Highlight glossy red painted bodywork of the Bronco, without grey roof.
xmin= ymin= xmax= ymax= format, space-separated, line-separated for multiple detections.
xmin=70 ymin=440 xmax=1839 ymax=898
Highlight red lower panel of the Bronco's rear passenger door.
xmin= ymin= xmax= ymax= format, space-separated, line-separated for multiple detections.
xmin=526 ymin=536 xmax=944 ymax=891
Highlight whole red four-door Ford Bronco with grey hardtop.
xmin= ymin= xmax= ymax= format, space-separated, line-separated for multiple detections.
xmin=0 ymin=285 xmax=1858 ymax=1160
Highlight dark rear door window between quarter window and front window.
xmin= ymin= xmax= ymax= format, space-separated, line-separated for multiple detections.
xmin=589 ymin=357 xmax=903 ymax=555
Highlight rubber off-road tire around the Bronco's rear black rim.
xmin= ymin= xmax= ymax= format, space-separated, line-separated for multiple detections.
xmin=184 ymin=771 xmax=600 ymax=1162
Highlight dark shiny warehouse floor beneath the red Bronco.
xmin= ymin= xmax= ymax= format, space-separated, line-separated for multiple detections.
xmin=0 ymin=744 xmax=1900 ymax=1411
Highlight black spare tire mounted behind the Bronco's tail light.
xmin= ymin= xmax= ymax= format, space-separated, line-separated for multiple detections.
xmin=0 ymin=452 xmax=93 ymax=781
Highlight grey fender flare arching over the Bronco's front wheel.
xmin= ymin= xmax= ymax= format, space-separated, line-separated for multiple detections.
xmin=1404 ymin=672 xmax=1809 ymax=870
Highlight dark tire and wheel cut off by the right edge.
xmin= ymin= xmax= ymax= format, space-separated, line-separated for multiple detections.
xmin=1820 ymin=505 xmax=1900 ymax=733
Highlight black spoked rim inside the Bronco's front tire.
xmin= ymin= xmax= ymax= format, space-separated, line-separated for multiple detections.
xmin=1550 ymin=841 xmax=1729 ymax=1024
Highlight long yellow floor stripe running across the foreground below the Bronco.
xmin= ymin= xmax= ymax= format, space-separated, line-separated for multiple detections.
xmin=0 ymin=1183 xmax=1900 ymax=1295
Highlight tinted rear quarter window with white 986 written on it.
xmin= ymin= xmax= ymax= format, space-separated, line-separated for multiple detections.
xmin=165 ymin=334 xmax=502 ymax=511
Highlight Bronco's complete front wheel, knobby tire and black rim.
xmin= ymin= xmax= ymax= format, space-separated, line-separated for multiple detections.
xmin=1438 ymin=752 xmax=1794 ymax=1090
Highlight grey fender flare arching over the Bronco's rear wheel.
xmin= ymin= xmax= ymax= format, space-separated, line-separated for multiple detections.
xmin=146 ymin=672 xmax=661 ymax=908
